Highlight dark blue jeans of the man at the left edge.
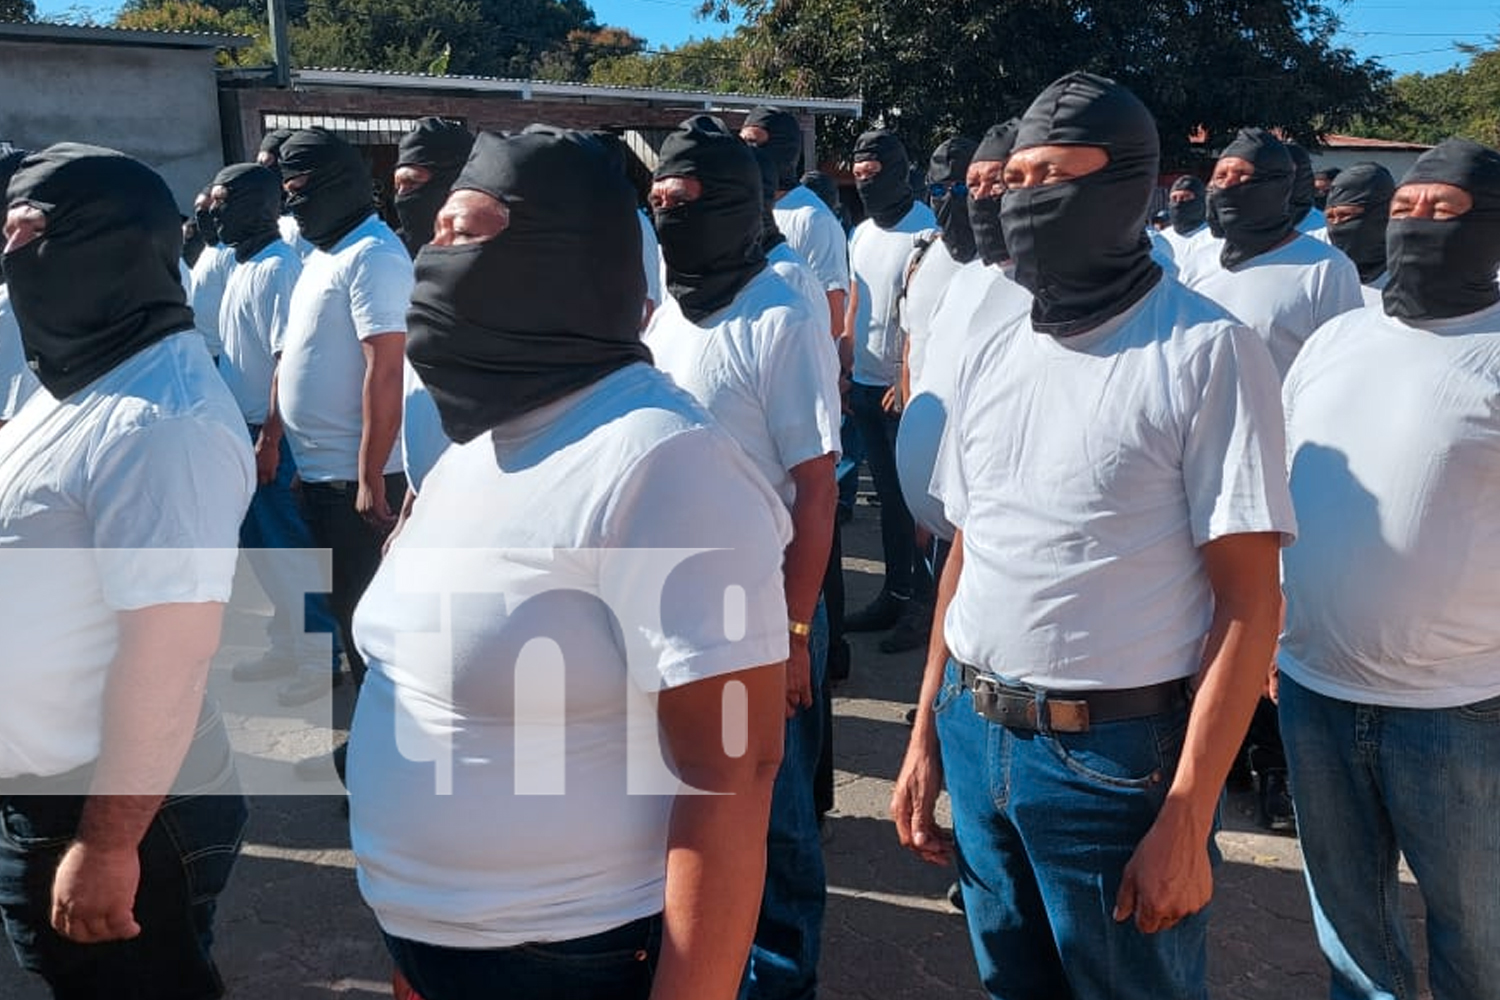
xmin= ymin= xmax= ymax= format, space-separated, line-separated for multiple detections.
xmin=0 ymin=761 xmax=248 ymax=1000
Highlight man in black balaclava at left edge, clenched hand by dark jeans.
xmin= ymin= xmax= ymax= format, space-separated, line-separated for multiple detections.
xmin=0 ymin=144 xmax=255 ymax=999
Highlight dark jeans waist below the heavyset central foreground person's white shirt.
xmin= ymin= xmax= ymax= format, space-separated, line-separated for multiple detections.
xmin=386 ymin=915 xmax=662 ymax=1000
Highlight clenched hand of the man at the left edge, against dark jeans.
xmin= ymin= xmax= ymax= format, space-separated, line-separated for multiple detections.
xmin=53 ymin=843 xmax=141 ymax=945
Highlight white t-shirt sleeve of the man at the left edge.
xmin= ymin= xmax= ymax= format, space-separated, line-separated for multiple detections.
xmin=84 ymin=414 xmax=255 ymax=612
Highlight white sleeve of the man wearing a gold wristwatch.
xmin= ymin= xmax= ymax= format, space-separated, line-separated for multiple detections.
xmin=759 ymin=312 xmax=842 ymax=471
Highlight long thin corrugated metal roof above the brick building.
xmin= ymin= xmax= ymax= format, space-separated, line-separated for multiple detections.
xmin=276 ymin=69 xmax=864 ymax=117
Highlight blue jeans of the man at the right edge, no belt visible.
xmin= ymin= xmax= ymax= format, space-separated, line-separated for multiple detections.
xmin=1280 ymin=673 xmax=1500 ymax=1000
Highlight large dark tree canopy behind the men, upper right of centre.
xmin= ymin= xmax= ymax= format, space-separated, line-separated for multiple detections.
xmin=702 ymin=0 xmax=1389 ymax=163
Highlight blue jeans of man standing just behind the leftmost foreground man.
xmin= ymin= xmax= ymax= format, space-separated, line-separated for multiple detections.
xmin=240 ymin=426 xmax=341 ymax=666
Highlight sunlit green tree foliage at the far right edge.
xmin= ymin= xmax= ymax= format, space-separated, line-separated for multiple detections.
xmin=1355 ymin=46 xmax=1500 ymax=147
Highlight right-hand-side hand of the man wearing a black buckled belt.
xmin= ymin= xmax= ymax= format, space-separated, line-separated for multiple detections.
xmin=1115 ymin=804 xmax=1214 ymax=934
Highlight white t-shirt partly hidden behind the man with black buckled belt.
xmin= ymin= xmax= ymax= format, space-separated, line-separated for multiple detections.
xmin=896 ymin=259 xmax=1032 ymax=540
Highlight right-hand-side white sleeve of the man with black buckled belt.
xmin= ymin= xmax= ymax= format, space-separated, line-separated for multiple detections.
xmin=1182 ymin=325 xmax=1298 ymax=546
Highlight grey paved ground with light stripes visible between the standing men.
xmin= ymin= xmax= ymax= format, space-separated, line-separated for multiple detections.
xmin=0 ymin=507 xmax=1422 ymax=1000
